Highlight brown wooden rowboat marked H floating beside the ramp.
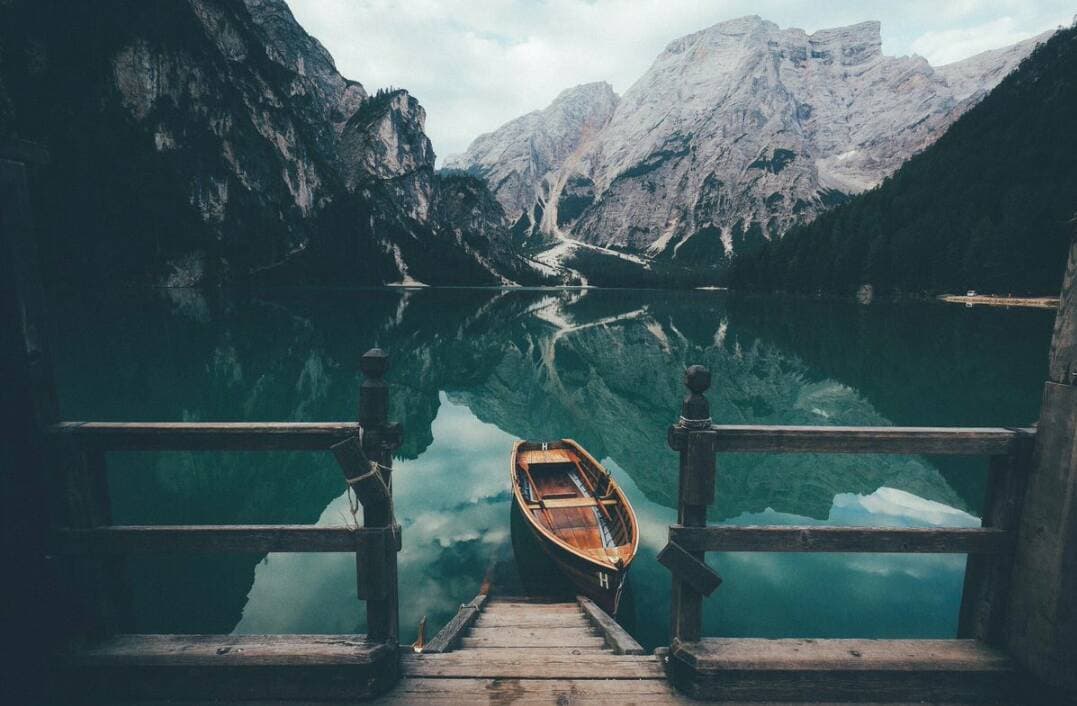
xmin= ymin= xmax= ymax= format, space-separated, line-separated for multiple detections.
xmin=509 ymin=439 xmax=640 ymax=615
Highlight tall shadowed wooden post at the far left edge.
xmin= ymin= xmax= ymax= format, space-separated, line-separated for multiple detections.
xmin=0 ymin=139 xmax=57 ymax=704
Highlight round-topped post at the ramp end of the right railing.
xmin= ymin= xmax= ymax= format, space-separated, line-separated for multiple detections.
xmin=669 ymin=365 xmax=715 ymax=643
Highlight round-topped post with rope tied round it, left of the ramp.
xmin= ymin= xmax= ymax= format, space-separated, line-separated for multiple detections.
xmin=356 ymin=348 xmax=401 ymax=644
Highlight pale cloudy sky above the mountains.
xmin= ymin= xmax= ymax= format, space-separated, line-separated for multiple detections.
xmin=288 ymin=0 xmax=1077 ymax=158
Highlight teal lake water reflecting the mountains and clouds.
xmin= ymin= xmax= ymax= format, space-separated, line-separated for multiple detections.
xmin=52 ymin=290 xmax=1053 ymax=648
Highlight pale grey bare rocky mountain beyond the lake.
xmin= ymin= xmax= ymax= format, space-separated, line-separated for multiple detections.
xmin=454 ymin=15 xmax=1041 ymax=281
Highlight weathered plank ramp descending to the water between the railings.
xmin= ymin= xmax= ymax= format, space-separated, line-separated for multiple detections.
xmin=373 ymin=595 xmax=693 ymax=706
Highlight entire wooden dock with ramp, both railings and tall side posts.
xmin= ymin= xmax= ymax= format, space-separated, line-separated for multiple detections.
xmin=0 ymin=139 xmax=1077 ymax=706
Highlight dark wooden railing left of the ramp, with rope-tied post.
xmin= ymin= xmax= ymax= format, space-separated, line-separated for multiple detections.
xmin=48 ymin=349 xmax=402 ymax=644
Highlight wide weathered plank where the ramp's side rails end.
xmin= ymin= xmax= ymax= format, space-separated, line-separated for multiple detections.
xmin=401 ymin=650 xmax=665 ymax=679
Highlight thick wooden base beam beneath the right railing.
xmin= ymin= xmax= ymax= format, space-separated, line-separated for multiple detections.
xmin=669 ymin=639 xmax=1016 ymax=703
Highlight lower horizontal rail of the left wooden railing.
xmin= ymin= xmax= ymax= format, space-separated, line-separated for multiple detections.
xmin=50 ymin=524 xmax=401 ymax=554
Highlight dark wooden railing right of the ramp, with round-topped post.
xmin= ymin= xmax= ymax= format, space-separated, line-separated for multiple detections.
xmin=658 ymin=366 xmax=1036 ymax=644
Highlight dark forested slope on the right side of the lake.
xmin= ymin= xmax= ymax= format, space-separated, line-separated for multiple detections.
xmin=729 ymin=28 xmax=1077 ymax=295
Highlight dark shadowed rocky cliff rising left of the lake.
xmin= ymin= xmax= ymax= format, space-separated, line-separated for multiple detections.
xmin=0 ymin=0 xmax=538 ymax=286
